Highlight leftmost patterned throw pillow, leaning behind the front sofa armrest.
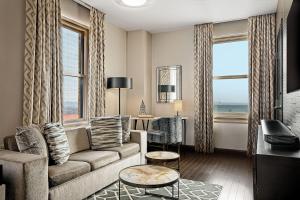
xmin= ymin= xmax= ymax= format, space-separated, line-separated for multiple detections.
xmin=15 ymin=125 xmax=48 ymax=157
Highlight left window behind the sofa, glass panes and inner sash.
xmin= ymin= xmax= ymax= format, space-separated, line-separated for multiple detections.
xmin=61 ymin=21 xmax=87 ymax=122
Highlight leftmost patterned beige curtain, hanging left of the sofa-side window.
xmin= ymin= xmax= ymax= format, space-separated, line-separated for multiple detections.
xmin=23 ymin=0 xmax=62 ymax=125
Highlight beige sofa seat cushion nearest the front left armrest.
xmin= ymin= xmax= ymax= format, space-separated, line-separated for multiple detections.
xmin=48 ymin=161 xmax=91 ymax=187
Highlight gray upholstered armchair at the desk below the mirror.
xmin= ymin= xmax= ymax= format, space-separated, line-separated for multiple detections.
xmin=147 ymin=116 xmax=183 ymax=153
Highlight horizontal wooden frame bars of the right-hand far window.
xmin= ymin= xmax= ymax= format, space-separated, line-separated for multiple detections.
xmin=213 ymin=34 xmax=249 ymax=124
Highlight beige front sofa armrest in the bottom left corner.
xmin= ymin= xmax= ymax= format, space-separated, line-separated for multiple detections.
xmin=0 ymin=150 xmax=49 ymax=200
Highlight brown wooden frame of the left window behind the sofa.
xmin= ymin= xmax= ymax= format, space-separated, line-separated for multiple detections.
xmin=61 ymin=17 xmax=89 ymax=126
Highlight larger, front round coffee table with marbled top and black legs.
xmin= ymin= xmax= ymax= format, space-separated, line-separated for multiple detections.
xmin=119 ymin=165 xmax=180 ymax=199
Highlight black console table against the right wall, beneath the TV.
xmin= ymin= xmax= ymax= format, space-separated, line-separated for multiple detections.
xmin=253 ymin=126 xmax=300 ymax=200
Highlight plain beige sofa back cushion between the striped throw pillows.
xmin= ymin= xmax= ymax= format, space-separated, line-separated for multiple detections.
xmin=66 ymin=128 xmax=90 ymax=154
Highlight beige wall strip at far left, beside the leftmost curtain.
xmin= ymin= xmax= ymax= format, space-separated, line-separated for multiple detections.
xmin=0 ymin=0 xmax=25 ymax=146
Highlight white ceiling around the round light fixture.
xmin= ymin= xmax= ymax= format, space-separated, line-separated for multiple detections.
xmin=81 ymin=0 xmax=278 ymax=33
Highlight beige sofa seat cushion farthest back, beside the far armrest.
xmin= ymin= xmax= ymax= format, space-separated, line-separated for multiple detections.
xmin=103 ymin=142 xmax=140 ymax=158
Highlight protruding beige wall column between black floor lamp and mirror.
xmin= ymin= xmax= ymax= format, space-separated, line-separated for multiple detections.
xmin=127 ymin=31 xmax=152 ymax=116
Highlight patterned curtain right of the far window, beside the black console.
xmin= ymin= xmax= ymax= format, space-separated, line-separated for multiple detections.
xmin=248 ymin=14 xmax=276 ymax=155
